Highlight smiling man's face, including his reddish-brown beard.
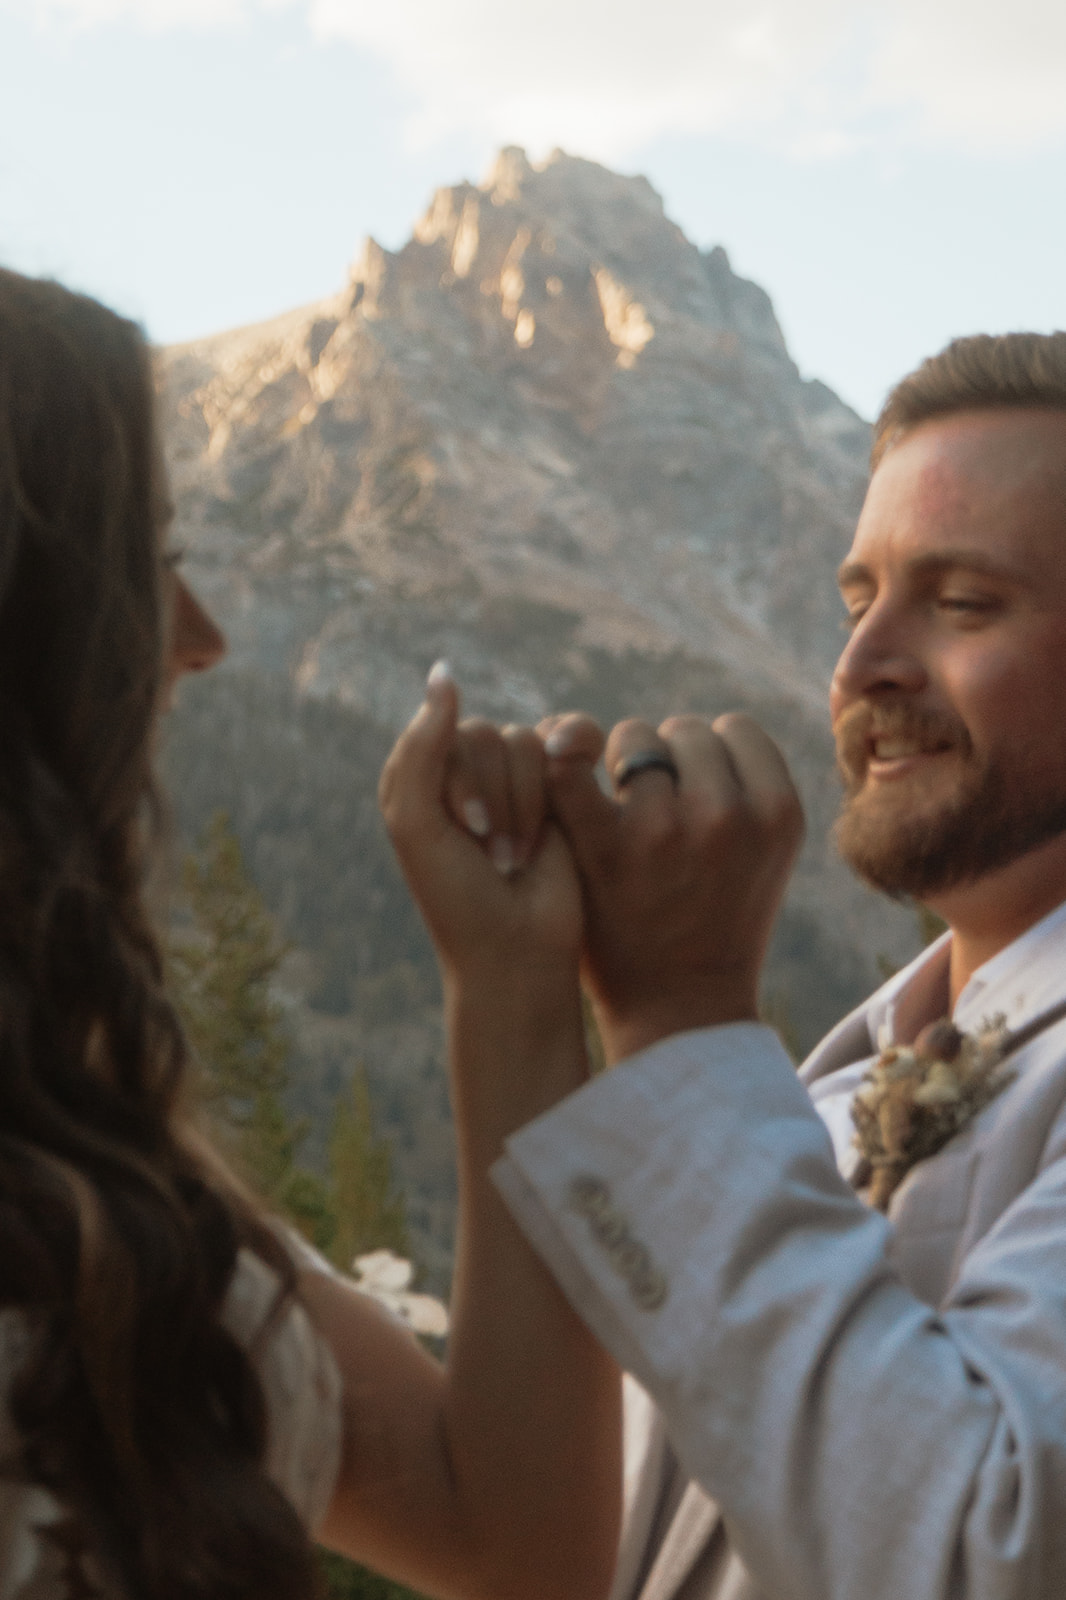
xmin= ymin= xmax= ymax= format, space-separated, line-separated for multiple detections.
xmin=829 ymin=408 xmax=1066 ymax=899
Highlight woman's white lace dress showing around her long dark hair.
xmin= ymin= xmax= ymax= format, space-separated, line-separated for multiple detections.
xmin=0 ymin=1250 xmax=341 ymax=1600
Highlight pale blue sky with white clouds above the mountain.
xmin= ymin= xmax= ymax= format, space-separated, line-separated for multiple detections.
xmin=0 ymin=0 xmax=1066 ymax=416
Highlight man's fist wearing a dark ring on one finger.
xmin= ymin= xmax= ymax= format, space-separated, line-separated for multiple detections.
xmin=539 ymin=714 xmax=804 ymax=1061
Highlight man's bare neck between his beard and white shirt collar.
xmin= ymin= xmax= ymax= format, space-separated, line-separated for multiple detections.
xmin=927 ymin=834 xmax=1066 ymax=1006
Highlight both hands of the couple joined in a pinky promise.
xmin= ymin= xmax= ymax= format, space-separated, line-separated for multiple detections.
xmin=381 ymin=674 xmax=802 ymax=1061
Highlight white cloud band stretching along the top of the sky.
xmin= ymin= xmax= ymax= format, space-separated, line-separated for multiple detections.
xmin=12 ymin=0 xmax=1066 ymax=160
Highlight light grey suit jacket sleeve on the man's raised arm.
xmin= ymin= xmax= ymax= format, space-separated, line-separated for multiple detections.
xmin=499 ymin=1027 xmax=1066 ymax=1600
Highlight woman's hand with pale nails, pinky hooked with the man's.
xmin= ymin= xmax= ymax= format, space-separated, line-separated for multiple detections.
xmin=378 ymin=664 xmax=581 ymax=981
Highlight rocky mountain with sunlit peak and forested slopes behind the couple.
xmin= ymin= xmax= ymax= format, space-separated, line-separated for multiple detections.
xmin=160 ymin=150 xmax=912 ymax=1272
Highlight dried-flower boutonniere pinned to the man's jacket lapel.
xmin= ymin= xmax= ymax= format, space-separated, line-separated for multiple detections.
xmin=852 ymin=1016 xmax=1011 ymax=1211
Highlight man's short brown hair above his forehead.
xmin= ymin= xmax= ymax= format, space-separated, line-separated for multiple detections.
xmin=871 ymin=333 xmax=1066 ymax=467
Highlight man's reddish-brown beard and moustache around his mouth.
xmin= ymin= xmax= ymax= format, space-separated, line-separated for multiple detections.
xmin=836 ymin=701 xmax=1066 ymax=901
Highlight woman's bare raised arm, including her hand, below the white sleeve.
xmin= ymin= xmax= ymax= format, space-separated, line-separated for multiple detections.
xmin=301 ymin=668 xmax=621 ymax=1600
